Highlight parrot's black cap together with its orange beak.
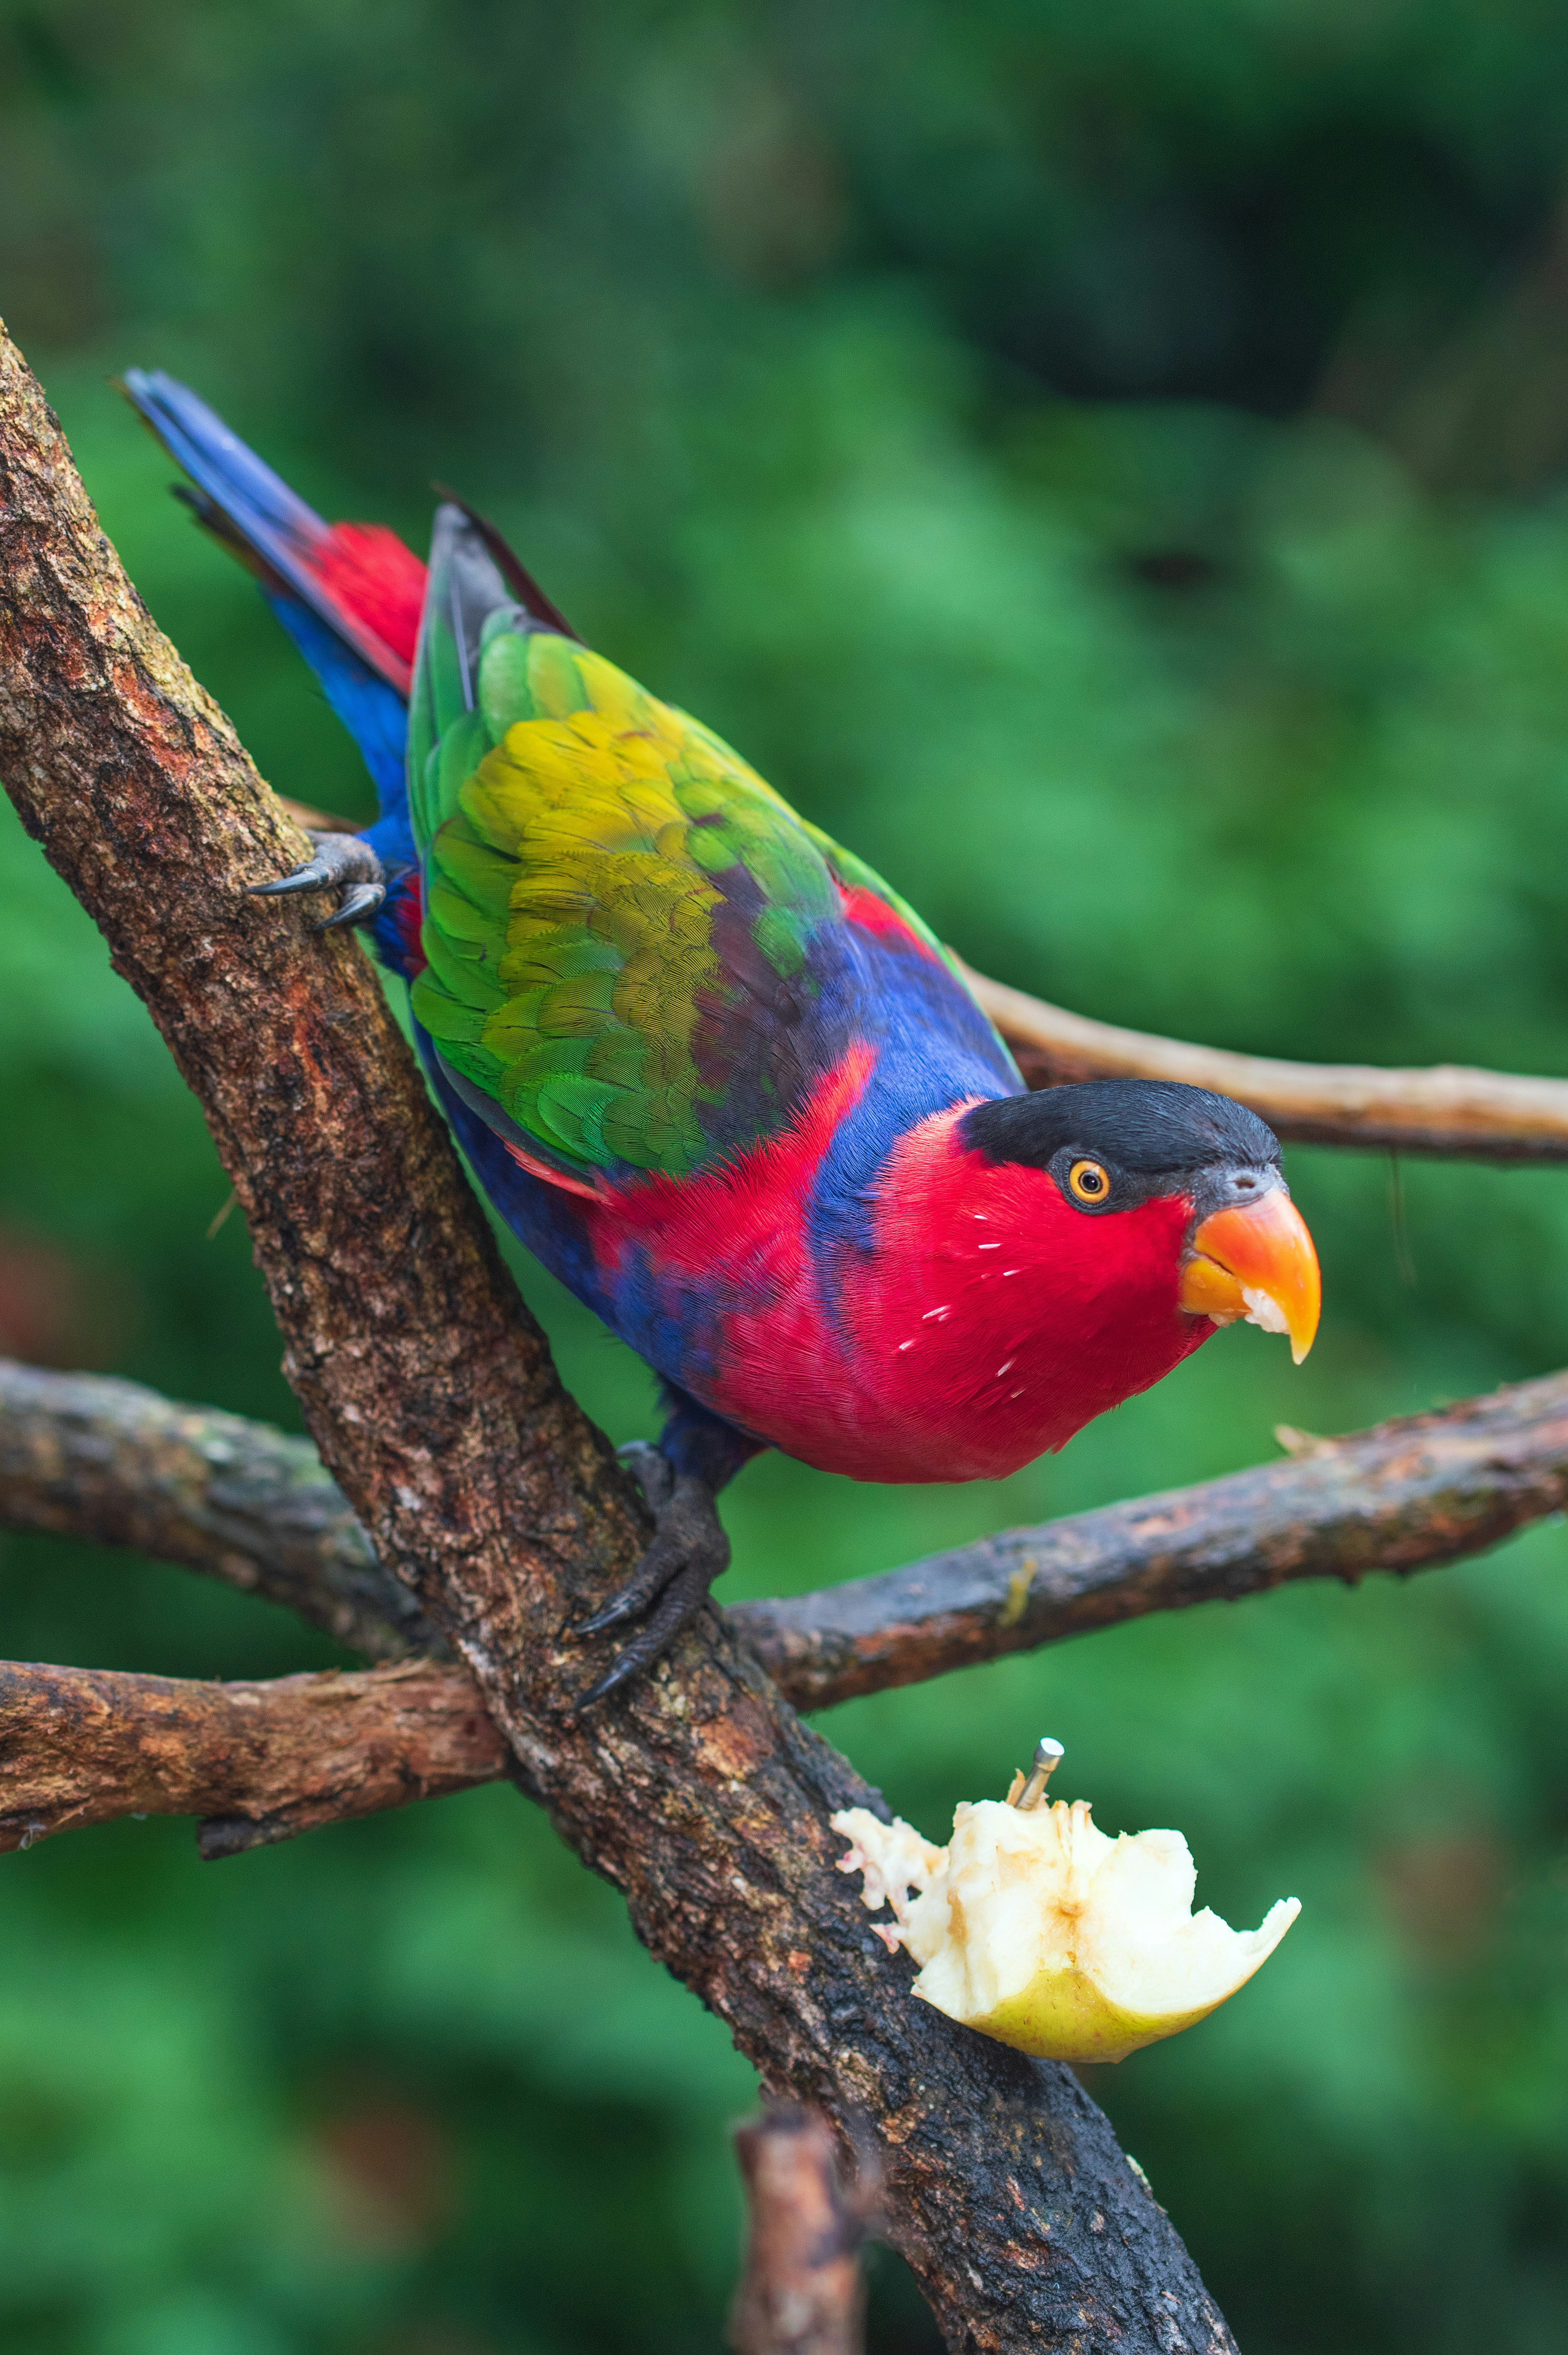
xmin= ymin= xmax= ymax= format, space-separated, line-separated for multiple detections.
xmin=958 ymin=1078 xmax=1323 ymax=1364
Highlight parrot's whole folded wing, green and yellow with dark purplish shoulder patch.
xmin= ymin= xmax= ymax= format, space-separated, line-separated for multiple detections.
xmin=410 ymin=509 xmax=1007 ymax=1184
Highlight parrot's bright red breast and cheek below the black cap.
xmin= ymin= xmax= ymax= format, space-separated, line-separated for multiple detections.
xmin=574 ymin=1074 xmax=1215 ymax=1481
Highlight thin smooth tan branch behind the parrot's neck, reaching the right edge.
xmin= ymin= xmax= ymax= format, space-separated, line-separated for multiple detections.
xmin=970 ymin=973 xmax=1568 ymax=1161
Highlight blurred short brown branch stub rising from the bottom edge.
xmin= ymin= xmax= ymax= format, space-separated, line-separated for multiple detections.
xmin=730 ymin=2103 xmax=866 ymax=2355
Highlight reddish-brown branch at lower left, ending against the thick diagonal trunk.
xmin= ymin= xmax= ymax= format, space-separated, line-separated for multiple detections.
xmin=0 ymin=1660 xmax=508 ymax=1856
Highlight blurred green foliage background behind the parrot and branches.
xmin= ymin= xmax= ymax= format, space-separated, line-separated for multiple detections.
xmin=0 ymin=0 xmax=1568 ymax=2355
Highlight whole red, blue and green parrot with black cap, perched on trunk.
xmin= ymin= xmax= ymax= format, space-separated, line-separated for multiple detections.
xmin=125 ymin=372 xmax=1319 ymax=1700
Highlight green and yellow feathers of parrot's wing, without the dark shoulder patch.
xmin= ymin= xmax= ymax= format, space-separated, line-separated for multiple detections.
xmin=410 ymin=527 xmax=838 ymax=1175
